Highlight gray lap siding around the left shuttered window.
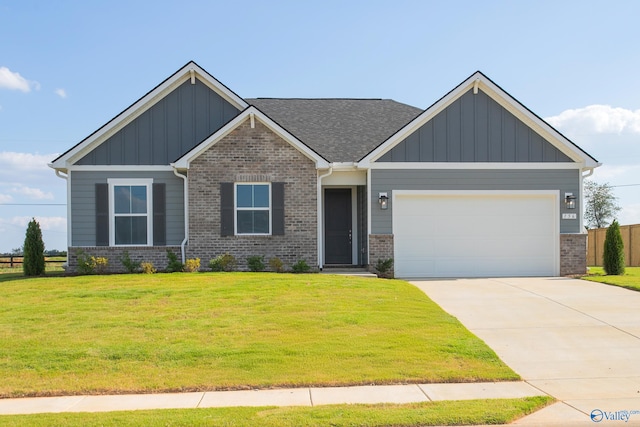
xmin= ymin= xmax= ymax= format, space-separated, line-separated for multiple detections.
xmin=71 ymin=171 xmax=184 ymax=246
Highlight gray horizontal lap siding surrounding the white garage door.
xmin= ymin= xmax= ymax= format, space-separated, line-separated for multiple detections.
xmin=370 ymin=169 xmax=582 ymax=234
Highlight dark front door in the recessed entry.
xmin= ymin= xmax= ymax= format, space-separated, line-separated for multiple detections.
xmin=324 ymin=188 xmax=352 ymax=264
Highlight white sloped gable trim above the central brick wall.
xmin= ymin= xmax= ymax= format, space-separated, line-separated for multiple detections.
xmin=171 ymin=106 xmax=329 ymax=170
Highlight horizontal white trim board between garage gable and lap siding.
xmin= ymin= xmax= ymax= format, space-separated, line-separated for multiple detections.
xmin=369 ymin=162 xmax=584 ymax=170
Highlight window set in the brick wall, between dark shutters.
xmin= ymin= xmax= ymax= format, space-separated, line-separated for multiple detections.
xmin=235 ymin=183 xmax=271 ymax=234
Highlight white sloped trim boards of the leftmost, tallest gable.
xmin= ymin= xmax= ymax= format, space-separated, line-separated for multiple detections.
xmin=50 ymin=61 xmax=248 ymax=170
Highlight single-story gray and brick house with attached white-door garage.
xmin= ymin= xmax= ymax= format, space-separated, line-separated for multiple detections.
xmin=50 ymin=62 xmax=600 ymax=277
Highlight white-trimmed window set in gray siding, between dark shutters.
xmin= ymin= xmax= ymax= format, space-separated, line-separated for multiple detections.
xmin=109 ymin=179 xmax=153 ymax=246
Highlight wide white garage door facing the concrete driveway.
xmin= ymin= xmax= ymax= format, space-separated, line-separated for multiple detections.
xmin=393 ymin=191 xmax=559 ymax=277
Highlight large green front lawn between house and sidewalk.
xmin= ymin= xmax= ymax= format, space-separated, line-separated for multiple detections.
xmin=0 ymin=273 xmax=518 ymax=397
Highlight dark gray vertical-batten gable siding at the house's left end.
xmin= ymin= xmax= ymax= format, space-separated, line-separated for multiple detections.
xmin=76 ymin=79 xmax=239 ymax=165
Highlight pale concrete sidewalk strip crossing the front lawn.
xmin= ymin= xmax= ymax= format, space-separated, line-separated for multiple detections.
xmin=0 ymin=382 xmax=544 ymax=415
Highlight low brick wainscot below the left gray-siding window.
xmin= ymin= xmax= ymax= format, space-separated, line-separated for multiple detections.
xmin=67 ymin=246 xmax=181 ymax=273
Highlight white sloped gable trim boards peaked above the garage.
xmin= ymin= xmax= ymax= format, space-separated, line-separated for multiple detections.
xmin=360 ymin=72 xmax=601 ymax=168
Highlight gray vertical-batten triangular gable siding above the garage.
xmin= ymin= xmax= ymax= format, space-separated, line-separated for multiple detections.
xmin=377 ymin=89 xmax=572 ymax=162
